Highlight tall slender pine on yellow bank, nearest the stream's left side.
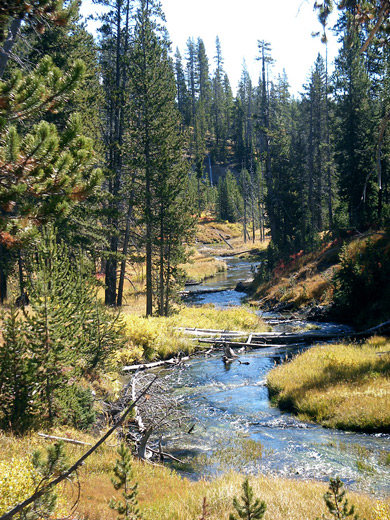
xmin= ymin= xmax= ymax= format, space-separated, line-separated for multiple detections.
xmin=130 ymin=0 xmax=193 ymax=315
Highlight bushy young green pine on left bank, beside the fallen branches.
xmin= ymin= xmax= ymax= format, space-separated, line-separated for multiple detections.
xmin=21 ymin=228 xmax=123 ymax=427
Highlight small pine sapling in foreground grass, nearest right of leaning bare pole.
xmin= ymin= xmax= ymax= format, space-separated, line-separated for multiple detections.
xmin=109 ymin=443 xmax=142 ymax=520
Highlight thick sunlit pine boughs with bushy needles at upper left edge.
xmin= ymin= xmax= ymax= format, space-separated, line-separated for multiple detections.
xmin=0 ymin=57 xmax=100 ymax=301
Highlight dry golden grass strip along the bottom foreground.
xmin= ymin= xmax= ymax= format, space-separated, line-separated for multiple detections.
xmin=0 ymin=431 xmax=390 ymax=520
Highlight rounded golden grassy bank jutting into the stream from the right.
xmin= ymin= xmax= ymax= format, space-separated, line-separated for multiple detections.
xmin=267 ymin=338 xmax=390 ymax=432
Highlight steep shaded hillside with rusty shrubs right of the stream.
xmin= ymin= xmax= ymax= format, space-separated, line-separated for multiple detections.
xmin=252 ymin=232 xmax=390 ymax=328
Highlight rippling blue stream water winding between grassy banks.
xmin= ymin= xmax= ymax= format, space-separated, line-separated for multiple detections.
xmin=161 ymin=258 xmax=390 ymax=495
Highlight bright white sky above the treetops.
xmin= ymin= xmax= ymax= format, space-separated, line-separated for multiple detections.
xmin=82 ymin=0 xmax=338 ymax=95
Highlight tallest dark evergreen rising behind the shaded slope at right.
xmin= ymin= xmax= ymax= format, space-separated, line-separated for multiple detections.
xmin=335 ymin=16 xmax=377 ymax=229
